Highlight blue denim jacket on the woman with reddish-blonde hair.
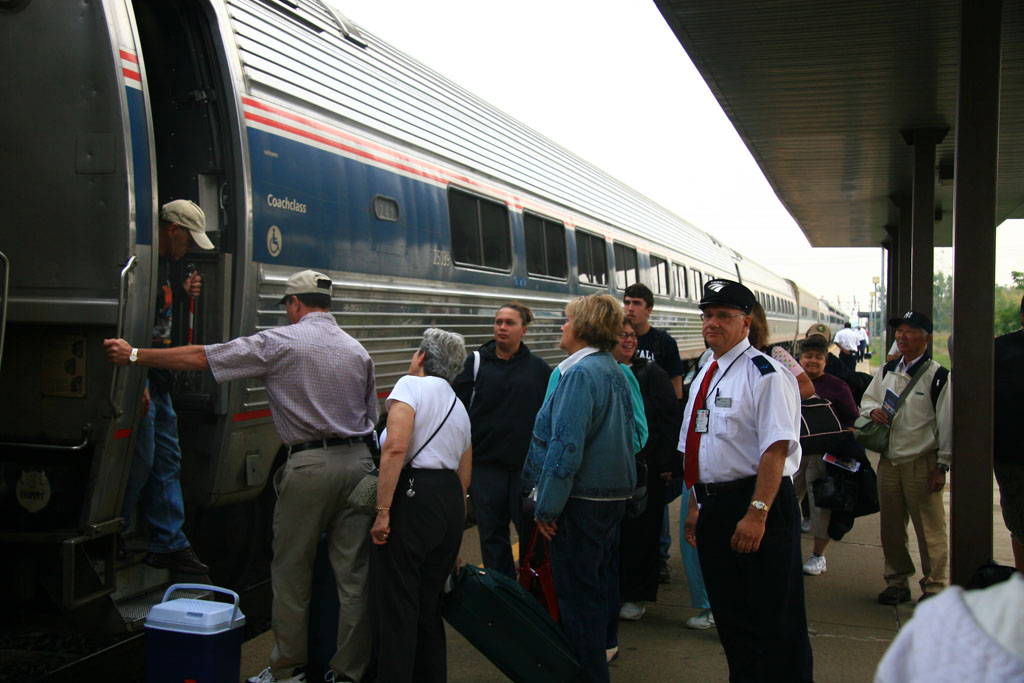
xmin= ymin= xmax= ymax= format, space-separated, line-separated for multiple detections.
xmin=522 ymin=352 xmax=636 ymax=521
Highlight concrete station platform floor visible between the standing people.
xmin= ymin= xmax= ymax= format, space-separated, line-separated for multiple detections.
xmin=242 ymin=456 xmax=1013 ymax=683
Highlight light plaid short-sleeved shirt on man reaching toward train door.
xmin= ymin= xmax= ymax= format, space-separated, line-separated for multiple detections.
xmin=206 ymin=311 xmax=379 ymax=444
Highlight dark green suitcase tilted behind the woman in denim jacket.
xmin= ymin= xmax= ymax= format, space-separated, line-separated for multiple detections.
xmin=444 ymin=564 xmax=580 ymax=682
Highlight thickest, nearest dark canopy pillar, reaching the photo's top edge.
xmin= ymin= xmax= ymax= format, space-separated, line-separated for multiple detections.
xmin=950 ymin=0 xmax=1002 ymax=586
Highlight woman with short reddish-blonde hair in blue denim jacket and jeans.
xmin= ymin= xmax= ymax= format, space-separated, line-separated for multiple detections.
xmin=523 ymin=295 xmax=636 ymax=681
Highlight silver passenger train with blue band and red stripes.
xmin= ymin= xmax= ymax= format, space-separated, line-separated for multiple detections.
xmin=0 ymin=0 xmax=845 ymax=671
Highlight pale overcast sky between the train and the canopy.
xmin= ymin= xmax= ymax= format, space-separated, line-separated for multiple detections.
xmin=330 ymin=0 xmax=1024 ymax=319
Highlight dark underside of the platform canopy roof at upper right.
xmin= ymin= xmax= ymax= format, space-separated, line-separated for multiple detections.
xmin=655 ymin=0 xmax=1024 ymax=247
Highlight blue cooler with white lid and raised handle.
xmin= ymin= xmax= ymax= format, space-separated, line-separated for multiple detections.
xmin=145 ymin=584 xmax=246 ymax=683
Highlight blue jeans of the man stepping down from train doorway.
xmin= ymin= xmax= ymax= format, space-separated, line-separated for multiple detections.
xmin=121 ymin=382 xmax=188 ymax=553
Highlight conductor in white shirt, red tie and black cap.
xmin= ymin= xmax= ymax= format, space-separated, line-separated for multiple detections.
xmin=679 ymin=280 xmax=812 ymax=681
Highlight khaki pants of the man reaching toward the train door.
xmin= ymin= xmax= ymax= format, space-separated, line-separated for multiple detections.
xmin=270 ymin=443 xmax=373 ymax=681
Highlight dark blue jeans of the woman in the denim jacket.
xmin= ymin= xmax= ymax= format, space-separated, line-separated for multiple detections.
xmin=550 ymin=498 xmax=626 ymax=682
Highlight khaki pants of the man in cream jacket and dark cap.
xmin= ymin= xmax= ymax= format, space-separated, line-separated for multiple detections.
xmin=878 ymin=452 xmax=949 ymax=593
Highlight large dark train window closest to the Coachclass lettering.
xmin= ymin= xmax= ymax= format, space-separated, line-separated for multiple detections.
xmin=449 ymin=187 xmax=512 ymax=270
